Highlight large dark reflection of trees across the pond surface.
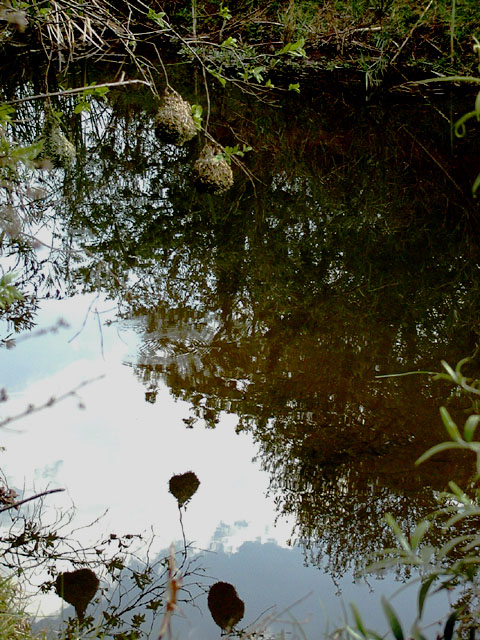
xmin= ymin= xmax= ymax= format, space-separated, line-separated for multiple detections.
xmin=3 ymin=65 xmax=478 ymax=572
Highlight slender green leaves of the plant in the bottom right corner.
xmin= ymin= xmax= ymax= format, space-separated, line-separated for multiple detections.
xmin=345 ymin=358 xmax=480 ymax=640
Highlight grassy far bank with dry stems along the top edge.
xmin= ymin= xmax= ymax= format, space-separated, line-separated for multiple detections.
xmin=0 ymin=0 xmax=480 ymax=95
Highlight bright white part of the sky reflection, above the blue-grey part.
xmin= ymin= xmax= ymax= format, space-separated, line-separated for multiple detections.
xmin=0 ymin=297 xmax=290 ymax=547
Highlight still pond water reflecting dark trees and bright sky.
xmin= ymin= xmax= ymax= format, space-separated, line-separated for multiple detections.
xmin=0 ymin=61 xmax=480 ymax=639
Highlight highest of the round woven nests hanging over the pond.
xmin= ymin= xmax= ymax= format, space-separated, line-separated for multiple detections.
xmin=155 ymin=89 xmax=197 ymax=146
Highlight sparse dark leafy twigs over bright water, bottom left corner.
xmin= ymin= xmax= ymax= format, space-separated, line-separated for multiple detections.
xmin=0 ymin=458 xmax=202 ymax=640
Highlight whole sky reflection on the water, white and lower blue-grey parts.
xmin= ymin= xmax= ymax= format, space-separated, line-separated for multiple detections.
xmin=0 ymin=297 xmax=450 ymax=640
